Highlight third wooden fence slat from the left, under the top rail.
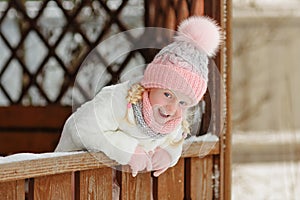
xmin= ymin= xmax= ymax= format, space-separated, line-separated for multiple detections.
xmin=75 ymin=167 xmax=113 ymax=200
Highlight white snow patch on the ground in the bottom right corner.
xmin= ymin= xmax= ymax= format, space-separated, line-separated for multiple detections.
xmin=232 ymin=162 xmax=300 ymax=200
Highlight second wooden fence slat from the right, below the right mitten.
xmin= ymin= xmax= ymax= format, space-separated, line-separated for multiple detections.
xmin=157 ymin=158 xmax=184 ymax=200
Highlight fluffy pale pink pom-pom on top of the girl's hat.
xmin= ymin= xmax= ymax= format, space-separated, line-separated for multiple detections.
xmin=175 ymin=16 xmax=222 ymax=57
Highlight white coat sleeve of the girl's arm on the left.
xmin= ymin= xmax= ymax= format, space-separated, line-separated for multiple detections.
xmin=56 ymin=84 xmax=138 ymax=165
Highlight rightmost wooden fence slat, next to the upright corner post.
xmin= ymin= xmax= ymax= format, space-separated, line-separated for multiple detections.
xmin=190 ymin=156 xmax=213 ymax=200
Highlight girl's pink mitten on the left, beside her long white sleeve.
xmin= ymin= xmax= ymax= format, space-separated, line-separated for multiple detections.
xmin=128 ymin=146 xmax=152 ymax=177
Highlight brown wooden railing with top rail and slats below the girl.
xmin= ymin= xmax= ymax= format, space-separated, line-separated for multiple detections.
xmin=0 ymin=142 xmax=219 ymax=200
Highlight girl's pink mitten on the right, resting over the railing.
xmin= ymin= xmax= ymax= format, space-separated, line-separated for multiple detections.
xmin=152 ymin=147 xmax=171 ymax=177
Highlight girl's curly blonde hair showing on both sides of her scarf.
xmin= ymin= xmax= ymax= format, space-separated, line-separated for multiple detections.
xmin=125 ymin=83 xmax=190 ymax=144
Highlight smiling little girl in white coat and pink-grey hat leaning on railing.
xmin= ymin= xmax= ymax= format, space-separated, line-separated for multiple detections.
xmin=56 ymin=17 xmax=221 ymax=176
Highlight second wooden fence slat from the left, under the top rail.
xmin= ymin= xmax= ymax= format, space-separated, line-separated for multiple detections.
xmin=33 ymin=172 xmax=74 ymax=200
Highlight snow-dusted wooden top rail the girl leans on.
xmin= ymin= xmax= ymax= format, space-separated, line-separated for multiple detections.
xmin=0 ymin=142 xmax=219 ymax=182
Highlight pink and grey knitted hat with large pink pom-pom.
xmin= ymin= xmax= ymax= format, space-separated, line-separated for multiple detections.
xmin=141 ymin=16 xmax=222 ymax=105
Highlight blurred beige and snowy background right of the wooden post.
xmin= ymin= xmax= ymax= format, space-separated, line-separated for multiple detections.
xmin=231 ymin=0 xmax=300 ymax=200
